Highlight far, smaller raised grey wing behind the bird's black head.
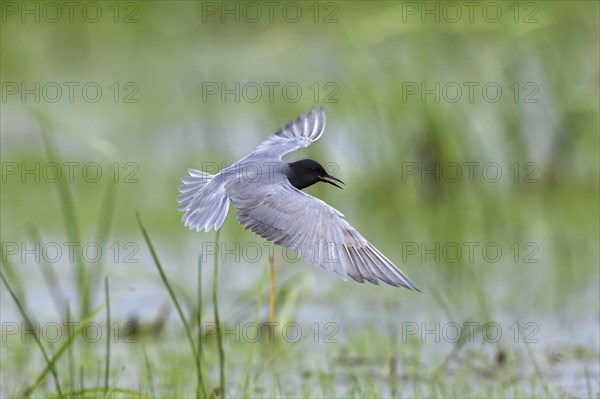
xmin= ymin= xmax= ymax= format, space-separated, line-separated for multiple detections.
xmin=250 ymin=107 xmax=326 ymax=159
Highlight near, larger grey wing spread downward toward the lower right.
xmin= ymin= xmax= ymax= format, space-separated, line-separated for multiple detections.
xmin=228 ymin=180 xmax=419 ymax=291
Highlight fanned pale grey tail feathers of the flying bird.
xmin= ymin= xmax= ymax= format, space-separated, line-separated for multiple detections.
xmin=177 ymin=169 xmax=229 ymax=231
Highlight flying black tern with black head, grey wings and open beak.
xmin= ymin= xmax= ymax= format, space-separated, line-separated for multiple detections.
xmin=177 ymin=108 xmax=420 ymax=291
